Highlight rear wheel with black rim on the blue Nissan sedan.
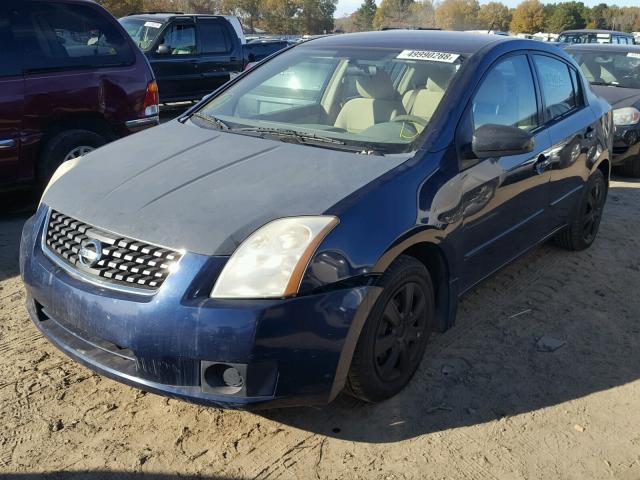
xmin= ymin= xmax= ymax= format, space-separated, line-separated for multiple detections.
xmin=554 ymin=170 xmax=607 ymax=251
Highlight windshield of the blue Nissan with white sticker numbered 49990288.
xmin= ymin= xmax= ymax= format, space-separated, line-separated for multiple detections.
xmin=194 ymin=46 xmax=461 ymax=154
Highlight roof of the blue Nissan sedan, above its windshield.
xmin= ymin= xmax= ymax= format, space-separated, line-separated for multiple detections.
xmin=300 ymin=30 xmax=516 ymax=54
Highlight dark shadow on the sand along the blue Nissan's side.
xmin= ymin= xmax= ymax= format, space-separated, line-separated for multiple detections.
xmin=259 ymin=181 xmax=640 ymax=443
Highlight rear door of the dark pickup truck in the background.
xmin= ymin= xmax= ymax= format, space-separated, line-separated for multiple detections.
xmin=197 ymin=18 xmax=242 ymax=96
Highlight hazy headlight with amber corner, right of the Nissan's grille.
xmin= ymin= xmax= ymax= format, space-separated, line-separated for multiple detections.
xmin=211 ymin=217 xmax=338 ymax=298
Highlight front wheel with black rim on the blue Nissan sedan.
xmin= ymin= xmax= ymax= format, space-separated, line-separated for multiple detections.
xmin=346 ymin=255 xmax=435 ymax=402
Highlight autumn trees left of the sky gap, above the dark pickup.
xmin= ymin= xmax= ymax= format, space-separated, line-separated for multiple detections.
xmin=97 ymin=0 xmax=338 ymax=35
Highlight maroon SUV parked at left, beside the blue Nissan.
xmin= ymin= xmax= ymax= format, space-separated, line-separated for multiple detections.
xmin=0 ymin=0 xmax=158 ymax=188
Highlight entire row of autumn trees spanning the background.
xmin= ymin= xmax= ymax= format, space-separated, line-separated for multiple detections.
xmin=98 ymin=0 xmax=640 ymax=35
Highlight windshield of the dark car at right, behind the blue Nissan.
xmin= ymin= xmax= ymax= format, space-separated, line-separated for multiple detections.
xmin=569 ymin=51 xmax=640 ymax=88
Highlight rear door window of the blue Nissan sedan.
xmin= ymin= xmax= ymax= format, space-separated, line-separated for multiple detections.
xmin=533 ymin=55 xmax=581 ymax=121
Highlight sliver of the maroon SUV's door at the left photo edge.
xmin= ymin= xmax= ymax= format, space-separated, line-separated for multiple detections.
xmin=0 ymin=5 xmax=24 ymax=185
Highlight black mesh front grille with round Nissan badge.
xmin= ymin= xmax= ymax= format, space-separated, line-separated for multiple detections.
xmin=44 ymin=210 xmax=181 ymax=291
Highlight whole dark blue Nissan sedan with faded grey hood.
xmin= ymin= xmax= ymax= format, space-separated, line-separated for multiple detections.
xmin=20 ymin=31 xmax=612 ymax=408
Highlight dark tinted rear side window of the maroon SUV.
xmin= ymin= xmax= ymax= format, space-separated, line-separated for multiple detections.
xmin=12 ymin=2 xmax=135 ymax=70
